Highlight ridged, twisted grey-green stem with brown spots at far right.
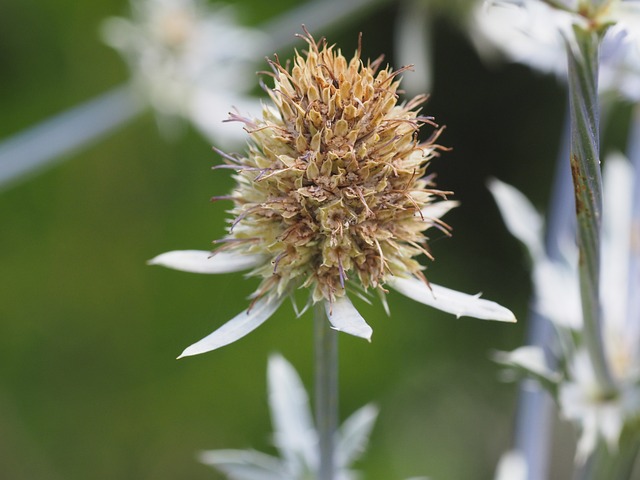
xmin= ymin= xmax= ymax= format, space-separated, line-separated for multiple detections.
xmin=567 ymin=26 xmax=615 ymax=395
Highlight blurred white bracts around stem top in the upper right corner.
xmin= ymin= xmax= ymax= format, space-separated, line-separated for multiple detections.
xmin=470 ymin=0 xmax=640 ymax=100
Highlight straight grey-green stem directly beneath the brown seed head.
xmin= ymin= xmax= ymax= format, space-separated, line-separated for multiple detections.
xmin=313 ymin=302 xmax=338 ymax=480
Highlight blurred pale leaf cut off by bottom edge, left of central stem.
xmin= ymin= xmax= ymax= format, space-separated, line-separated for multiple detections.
xmin=198 ymin=450 xmax=286 ymax=480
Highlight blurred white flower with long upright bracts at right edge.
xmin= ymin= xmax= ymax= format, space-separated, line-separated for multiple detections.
xmin=490 ymin=154 xmax=640 ymax=461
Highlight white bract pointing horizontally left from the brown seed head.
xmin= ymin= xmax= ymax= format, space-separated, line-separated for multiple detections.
xmin=147 ymin=250 xmax=264 ymax=273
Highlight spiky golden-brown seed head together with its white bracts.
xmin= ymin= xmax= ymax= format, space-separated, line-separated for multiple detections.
xmin=150 ymin=34 xmax=515 ymax=356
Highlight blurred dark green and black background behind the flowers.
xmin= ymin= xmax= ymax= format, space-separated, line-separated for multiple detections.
xmin=0 ymin=0 xmax=576 ymax=480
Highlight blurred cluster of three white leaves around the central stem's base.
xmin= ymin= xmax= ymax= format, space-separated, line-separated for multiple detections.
xmin=199 ymin=355 xmax=378 ymax=480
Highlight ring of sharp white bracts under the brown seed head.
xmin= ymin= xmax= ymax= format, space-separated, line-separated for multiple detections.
xmin=148 ymin=197 xmax=516 ymax=358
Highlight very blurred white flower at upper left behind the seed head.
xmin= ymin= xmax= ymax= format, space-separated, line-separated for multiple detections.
xmin=103 ymin=0 xmax=266 ymax=145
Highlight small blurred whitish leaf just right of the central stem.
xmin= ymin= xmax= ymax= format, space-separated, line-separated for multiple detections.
xmin=336 ymin=404 xmax=378 ymax=469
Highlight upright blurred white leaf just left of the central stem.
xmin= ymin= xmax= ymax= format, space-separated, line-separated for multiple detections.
xmin=267 ymin=355 xmax=318 ymax=469
